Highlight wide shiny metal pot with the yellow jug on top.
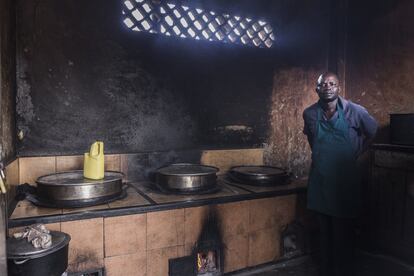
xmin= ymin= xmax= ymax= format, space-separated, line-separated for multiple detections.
xmin=36 ymin=171 xmax=123 ymax=207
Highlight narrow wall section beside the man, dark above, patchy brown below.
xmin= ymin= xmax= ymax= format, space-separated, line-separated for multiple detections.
xmin=265 ymin=0 xmax=335 ymax=176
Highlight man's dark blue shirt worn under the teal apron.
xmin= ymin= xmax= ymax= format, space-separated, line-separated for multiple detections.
xmin=303 ymin=97 xmax=378 ymax=156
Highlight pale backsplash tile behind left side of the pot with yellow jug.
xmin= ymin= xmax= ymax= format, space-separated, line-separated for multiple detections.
xmin=19 ymin=156 xmax=56 ymax=184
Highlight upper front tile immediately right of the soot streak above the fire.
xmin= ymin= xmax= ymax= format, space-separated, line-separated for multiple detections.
xmin=217 ymin=201 xmax=249 ymax=237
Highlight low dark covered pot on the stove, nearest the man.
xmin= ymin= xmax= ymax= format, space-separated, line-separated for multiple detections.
xmin=227 ymin=166 xmax=290 ymax=186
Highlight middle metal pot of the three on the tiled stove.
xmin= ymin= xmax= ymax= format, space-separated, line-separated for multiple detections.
xmin=155 ymin=163 xmax=219 ymax=193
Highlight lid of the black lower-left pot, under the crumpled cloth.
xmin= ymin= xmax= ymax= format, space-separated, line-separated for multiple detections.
xmin=7 ymin=231 xmax=70 ymax=259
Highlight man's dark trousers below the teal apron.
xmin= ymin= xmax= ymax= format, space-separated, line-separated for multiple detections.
xmin=318 ymin=213 xmax=355 ymax=276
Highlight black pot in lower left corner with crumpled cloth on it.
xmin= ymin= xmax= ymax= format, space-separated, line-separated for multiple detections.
xmin=7 ymin=231 xmax=70 ymax=276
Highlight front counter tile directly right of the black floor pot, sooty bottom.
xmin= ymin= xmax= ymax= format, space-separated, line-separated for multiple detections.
xmin=61 ymin=218 xmax=104 ymax=272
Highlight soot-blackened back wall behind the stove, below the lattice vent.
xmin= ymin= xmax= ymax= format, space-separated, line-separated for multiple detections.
xmin=17 ymin=0 xmax=281 ymax=156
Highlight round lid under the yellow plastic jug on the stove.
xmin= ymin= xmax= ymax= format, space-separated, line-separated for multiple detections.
xmin=36 ymin=170 xmax=123 ymax=186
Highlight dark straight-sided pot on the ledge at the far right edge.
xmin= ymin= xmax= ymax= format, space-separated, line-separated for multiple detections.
xmin=390 ymin=113 xmax=414 ymax=146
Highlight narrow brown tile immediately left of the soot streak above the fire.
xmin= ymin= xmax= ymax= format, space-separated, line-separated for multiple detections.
xmin=184 ymin=206 xmax=209 ymax=245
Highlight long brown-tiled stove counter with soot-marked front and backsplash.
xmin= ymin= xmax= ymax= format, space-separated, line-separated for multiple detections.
xmin=6 ymin=149 xmax=306 ymax=276
